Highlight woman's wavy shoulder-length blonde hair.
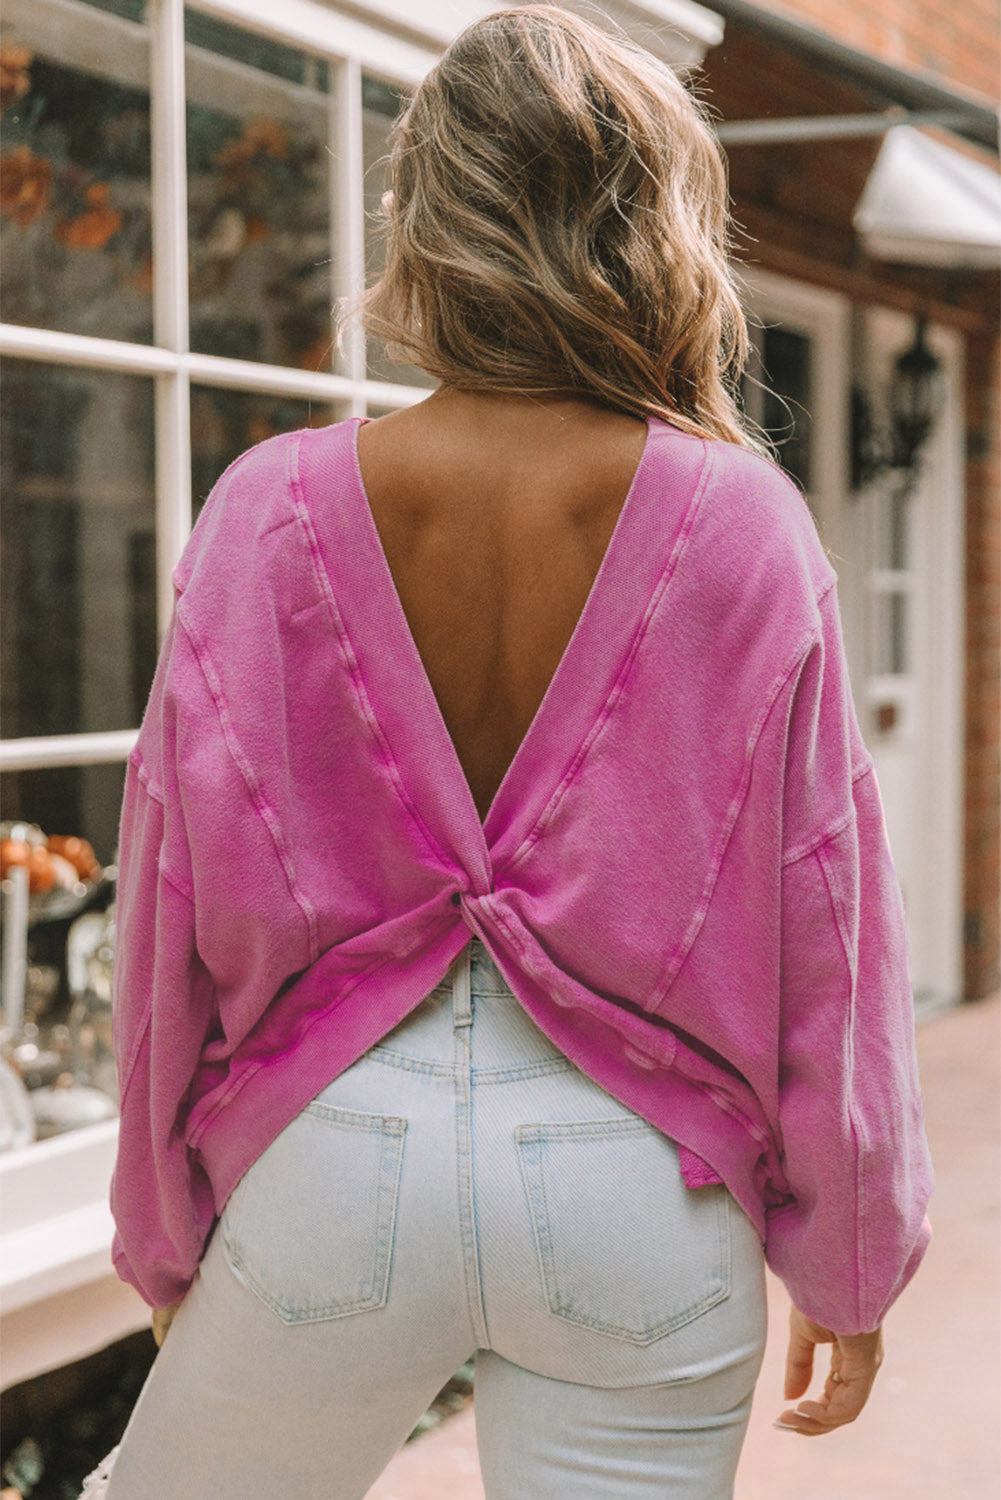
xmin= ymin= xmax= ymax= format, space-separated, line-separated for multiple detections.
xmin=357 ymin=5 xmax=770 ymax=455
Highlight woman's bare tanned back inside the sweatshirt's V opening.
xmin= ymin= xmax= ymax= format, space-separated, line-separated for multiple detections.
xmin=354 ymin=419 xmax=650 ymax=816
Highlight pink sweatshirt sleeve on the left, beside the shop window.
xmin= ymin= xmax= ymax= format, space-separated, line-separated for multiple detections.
xmin=111 ymin=614 xmax=215 ymax=1307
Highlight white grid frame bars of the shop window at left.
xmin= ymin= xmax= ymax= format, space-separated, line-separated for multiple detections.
xmin=0 ymin=0 xmax=438 ymax=771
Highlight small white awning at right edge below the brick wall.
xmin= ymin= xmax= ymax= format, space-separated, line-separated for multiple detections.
xmin=852 ymin=125 xmax=1001 ymax=270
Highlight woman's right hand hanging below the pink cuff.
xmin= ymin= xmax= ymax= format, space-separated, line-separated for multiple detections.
xmin=774 ymin=1307 xmax=882 ymax=1437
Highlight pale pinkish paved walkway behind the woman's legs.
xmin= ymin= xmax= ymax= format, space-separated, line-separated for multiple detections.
xmin=368 ymin=995 xmax=1001 ymax=1500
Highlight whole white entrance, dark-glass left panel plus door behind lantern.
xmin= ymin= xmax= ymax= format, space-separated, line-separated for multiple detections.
xmin=744 ymin=272 xmax=963 ymax=1013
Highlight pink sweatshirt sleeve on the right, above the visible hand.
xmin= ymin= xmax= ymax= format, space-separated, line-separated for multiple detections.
xmin=768 ymin=573 xmax=933 ymax=1334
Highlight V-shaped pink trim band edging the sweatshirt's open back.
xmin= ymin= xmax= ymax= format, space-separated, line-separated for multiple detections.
xmin=305 ymin=417 xmax=704 ymax=870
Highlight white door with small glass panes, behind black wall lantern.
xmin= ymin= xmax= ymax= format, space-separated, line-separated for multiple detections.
xmin=851 ymin=308 xmax=965 ymax=1011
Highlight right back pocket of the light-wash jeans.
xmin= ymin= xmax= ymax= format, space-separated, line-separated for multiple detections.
xmin=515 ymin=1116 xmax=731 ymax=1344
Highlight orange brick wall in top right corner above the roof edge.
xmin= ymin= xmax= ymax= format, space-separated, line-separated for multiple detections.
xmin=767 ymin=0 xmax=1001 ymax=101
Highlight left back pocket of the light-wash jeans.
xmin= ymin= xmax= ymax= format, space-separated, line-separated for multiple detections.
xmin=219 ymin=1100 xmax=407 ymax=1323
